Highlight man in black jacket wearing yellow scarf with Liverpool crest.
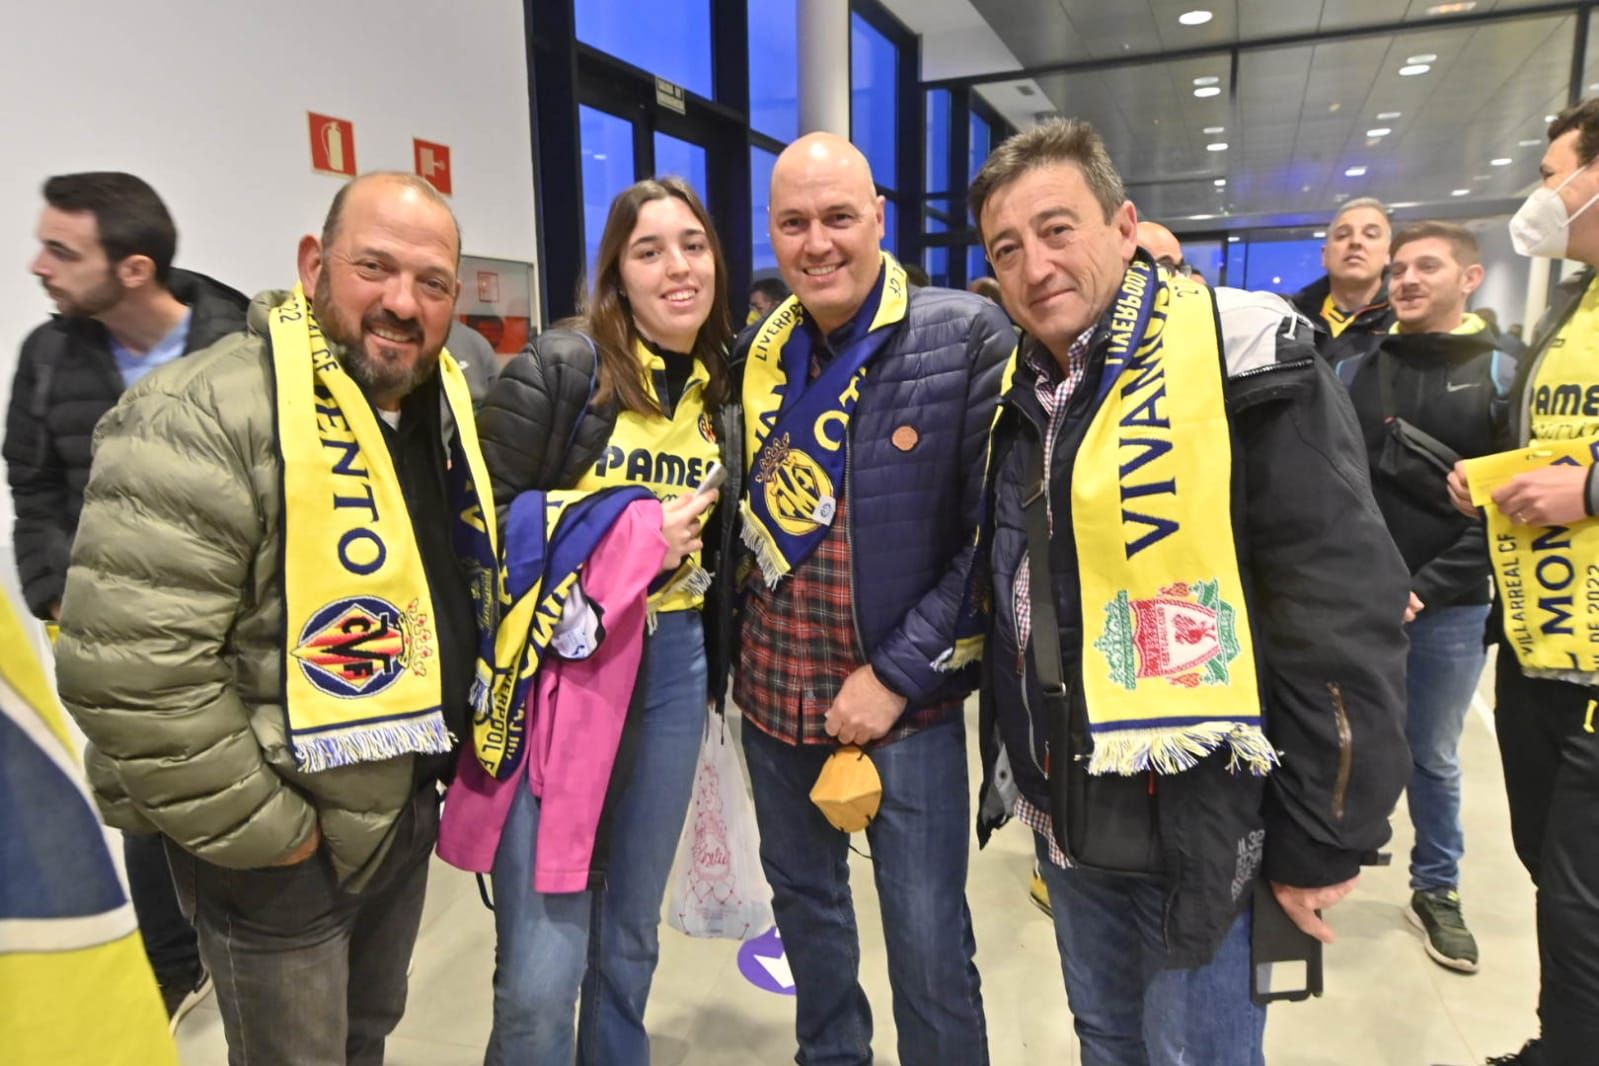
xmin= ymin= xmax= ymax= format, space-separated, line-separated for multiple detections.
xmin=969 ymin=120 xmax=1404 ymax=1066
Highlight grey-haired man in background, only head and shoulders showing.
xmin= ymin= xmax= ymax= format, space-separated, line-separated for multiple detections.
xmin=1292 ymin=197 xmax=1394 ymax=363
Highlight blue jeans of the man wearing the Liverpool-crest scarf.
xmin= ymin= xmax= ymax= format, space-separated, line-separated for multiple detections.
xmin=1035 ymin=834 xmax=1266 ymax=1066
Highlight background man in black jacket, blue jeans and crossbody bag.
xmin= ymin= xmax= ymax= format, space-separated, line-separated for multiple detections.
xmin=1337 ymin=222 xmax=1516 ymax=973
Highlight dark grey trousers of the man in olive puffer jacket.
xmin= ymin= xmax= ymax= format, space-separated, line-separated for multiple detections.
xmin=171 ymin=786 xmax=438 ymax=1066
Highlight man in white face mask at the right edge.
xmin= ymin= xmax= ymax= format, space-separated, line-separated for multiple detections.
xmin=1449 ymin=99 xmax=1599 ymax=1066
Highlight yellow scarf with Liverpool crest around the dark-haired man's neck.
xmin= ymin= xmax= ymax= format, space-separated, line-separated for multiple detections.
xmin=1071 ymin=259 xmax=1276 ymax=774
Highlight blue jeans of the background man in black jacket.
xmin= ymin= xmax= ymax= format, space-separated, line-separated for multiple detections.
xmin=1406 ymin=604 xmax=1489 ymax=890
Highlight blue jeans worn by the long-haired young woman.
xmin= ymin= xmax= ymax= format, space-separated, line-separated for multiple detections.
xmin=484 ymin=611 xmax=705 ymax=1066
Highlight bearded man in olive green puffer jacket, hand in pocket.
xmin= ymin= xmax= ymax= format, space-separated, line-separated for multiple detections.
xmin=56 ymin=174 xmax=494 ymax=1063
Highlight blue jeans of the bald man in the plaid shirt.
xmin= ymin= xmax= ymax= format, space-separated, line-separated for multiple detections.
xmin=742 ymin=721 xmax=988 ymax=1066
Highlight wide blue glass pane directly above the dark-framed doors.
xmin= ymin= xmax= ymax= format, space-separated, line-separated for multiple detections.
xmin=572 ymin=0 xmax=713 ymax=97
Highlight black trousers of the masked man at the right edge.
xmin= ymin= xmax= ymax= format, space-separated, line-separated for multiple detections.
xmin=1493 ymin=644 xmax=1599 ymax=1066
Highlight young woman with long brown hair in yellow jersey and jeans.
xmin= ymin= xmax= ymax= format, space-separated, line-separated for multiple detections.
xmin=463 ymin=177 xmax=732 ymax=1066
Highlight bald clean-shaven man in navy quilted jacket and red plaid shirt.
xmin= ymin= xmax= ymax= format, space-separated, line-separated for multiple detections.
xmin=713 ymin=134 xmax=1015 ymax=1066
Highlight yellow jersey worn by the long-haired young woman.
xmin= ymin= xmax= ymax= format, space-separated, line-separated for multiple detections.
xmin=574 ymin=342 xmax=721 ymax=619
